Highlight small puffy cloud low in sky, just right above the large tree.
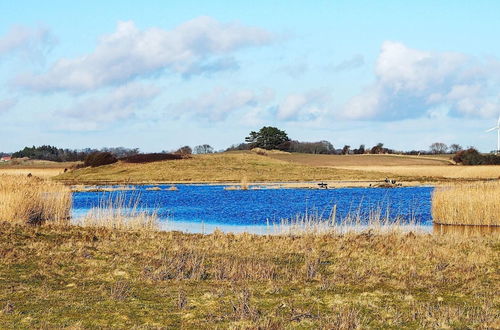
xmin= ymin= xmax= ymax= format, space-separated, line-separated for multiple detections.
xmin=276 ymin=91 xmax=329 ymax=121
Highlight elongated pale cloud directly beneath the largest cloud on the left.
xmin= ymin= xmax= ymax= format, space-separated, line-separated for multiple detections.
xmin=53 ymin=83 xmax=159 ymax=130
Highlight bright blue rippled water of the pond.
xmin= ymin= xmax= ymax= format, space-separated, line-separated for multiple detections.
xmin=73 ymin=185 xmax=433 ymax=226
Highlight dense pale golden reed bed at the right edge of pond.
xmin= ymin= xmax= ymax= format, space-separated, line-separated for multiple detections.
xmin=432 ymin=181 xmax=500 ymax=226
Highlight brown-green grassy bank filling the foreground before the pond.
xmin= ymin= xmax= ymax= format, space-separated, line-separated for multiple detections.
xmin=0 ymin=222 xmax=500 ymax=329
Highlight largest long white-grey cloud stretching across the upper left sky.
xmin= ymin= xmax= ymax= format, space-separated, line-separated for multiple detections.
xmin=14 ymin=17 xmax=273 ymax=91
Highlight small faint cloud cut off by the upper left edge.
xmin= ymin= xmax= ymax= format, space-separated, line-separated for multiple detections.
xmin=0 ymin=25 xmax=56 ymax=60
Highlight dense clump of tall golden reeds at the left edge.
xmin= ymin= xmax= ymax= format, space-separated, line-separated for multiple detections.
xmin=0 ymin=174 xmax=71 ymax=224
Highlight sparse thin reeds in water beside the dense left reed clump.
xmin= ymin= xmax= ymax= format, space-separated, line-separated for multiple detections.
xmin=73 ymin=193 xmax=159 ymax=231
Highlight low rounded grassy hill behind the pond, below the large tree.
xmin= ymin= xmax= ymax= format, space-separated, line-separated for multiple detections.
xmin=56 ymin=153 xmax=390 ymax=183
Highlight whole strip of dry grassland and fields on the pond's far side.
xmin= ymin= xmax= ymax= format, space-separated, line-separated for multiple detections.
xmin=52 ymin=152 xmax=500 ymax=186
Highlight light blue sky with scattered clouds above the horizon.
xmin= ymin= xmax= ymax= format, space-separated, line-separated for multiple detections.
xmin=0 ymin=0 xmax=500 ymax=152
